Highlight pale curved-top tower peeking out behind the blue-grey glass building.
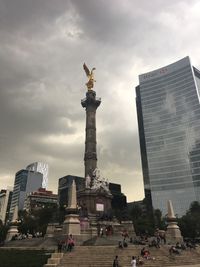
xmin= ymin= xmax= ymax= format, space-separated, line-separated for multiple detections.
xmin=26 ymin=162 xmax=49 ymax=188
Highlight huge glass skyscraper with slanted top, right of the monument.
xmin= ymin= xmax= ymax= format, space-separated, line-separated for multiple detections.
xmin=136 ymin=57 xmax=200 ymax=216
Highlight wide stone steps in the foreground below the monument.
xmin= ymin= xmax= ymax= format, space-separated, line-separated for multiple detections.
xmin=54 ymin=245 xmax=200 ymax=267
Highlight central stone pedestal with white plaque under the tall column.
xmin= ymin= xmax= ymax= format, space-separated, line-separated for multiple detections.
xmin=77 ymin=187 xmax=135 ymax=241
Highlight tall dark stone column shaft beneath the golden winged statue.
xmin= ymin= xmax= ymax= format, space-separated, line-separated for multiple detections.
xmin=81 ymin=90 xmax=101 ymax=177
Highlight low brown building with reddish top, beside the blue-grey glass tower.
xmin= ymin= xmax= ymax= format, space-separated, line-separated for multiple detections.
xmin=24 ymin=188 xmax=58 ymax=211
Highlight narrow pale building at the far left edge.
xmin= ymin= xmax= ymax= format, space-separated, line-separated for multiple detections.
xmin=0 ymin=187 xmax=13 ymax=224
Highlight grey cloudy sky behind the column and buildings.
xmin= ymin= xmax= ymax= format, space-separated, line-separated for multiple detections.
xmin=0 ymin=0 xmax=200 ymax=201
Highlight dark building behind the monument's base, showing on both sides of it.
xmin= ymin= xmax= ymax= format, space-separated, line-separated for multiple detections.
xmin=58 ymin=175 xmax=126 ymax=209
